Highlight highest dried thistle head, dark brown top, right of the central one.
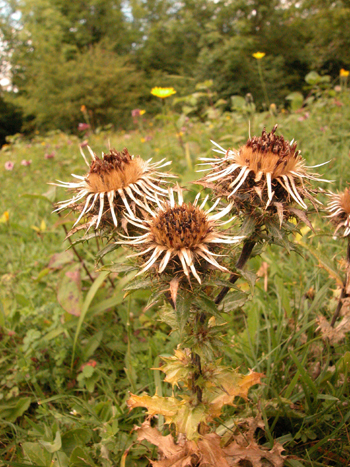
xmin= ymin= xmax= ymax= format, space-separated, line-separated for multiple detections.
xmin=197 ymin=125 xmax=329 ymax=209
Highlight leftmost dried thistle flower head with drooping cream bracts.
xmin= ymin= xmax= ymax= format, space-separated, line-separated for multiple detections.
xmin=52 ymin=146 xmax=174 ymax=232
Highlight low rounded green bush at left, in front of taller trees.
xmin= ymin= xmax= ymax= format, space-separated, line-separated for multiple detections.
xmin=14 ymin=45 xmax=142 ymax=131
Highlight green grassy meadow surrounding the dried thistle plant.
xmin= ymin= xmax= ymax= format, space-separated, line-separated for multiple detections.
xmin=0 ymin=93 xmax=350 ymax=467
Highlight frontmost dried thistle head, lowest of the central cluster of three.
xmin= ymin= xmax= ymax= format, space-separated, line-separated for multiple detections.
xmin=119 ymin=187 xmax=243 ymax=283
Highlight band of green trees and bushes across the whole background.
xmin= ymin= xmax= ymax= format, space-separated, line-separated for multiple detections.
xmin=0 ymin=0 xmax=350 ymax=135
